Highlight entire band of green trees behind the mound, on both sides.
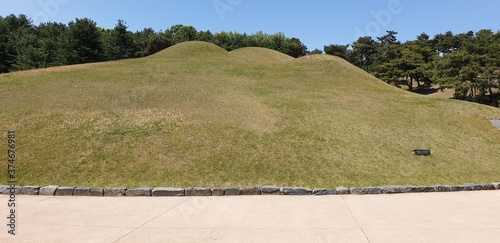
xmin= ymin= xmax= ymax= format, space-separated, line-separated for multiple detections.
xmin=0 ymin=15 xmax=500 ymax=106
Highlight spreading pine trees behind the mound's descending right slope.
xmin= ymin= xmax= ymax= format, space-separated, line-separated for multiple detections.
xmin=322 ymin=30 xmax=500 ymax=107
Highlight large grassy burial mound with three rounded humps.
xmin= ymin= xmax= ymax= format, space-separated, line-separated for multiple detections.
xmin=0 ymin=42 xmax=500 ymax=187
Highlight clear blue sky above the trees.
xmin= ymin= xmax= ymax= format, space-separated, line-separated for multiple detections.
xmin=0 ymin=0 xmax=500 ymax=50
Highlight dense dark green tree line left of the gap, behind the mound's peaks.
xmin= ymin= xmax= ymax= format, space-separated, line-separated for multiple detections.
xmin=0 ymin=15 xmax=307 ymax=73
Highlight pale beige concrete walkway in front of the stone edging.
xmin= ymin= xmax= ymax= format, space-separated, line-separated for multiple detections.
xmin=0 ymin=191 xmax=500 ymax=243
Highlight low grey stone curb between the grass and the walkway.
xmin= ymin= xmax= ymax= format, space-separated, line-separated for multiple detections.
xmin=0 ymin=182 xmax=500 ymax=197
